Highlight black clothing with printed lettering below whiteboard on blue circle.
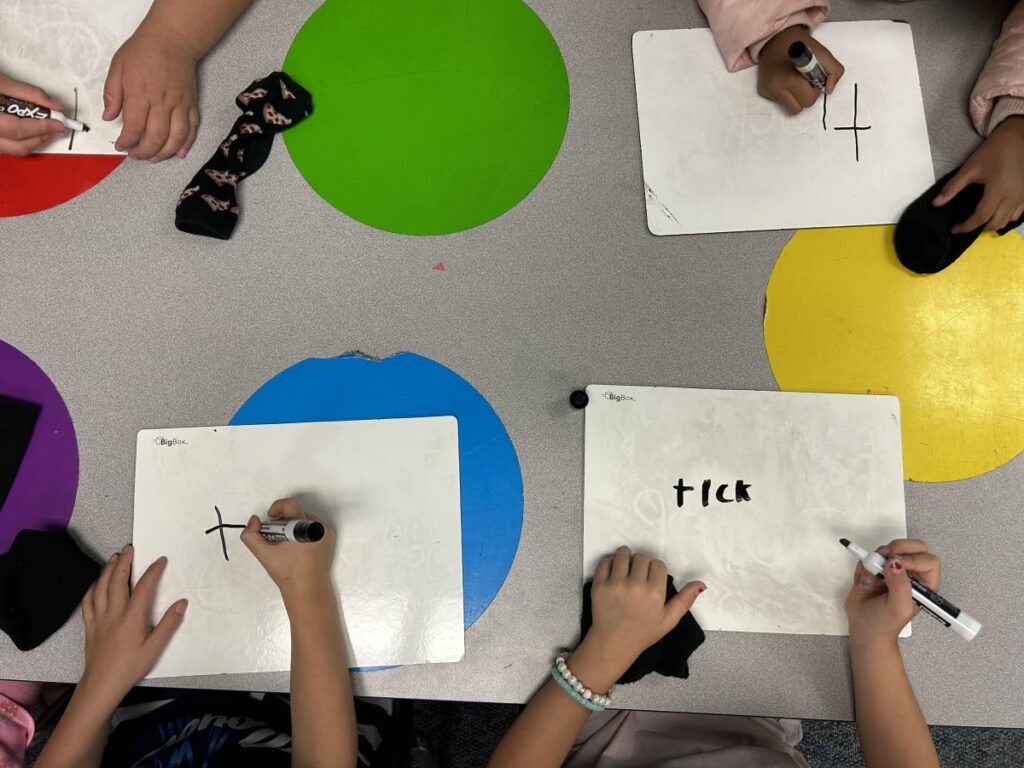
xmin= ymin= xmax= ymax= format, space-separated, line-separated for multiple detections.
xmin=101 ymin=688 xmax=391 ymax=768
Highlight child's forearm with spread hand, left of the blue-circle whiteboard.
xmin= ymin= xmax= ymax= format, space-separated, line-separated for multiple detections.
xmin=36 ymin=544 xmax=187 ymax=768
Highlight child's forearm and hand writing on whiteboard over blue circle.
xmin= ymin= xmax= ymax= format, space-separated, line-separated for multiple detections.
xmin=242 ymin=499 xmax=358 ymax=768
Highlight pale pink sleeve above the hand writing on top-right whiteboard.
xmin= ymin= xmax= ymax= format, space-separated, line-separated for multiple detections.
xmin=697 ymin=0 xmax=828 ymax=72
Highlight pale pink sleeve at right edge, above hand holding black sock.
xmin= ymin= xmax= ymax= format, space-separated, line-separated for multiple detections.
xmin=971 ymin=3 xmax=1024 ymax=136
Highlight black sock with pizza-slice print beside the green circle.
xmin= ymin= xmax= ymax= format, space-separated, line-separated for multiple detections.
xmin=174 ymin=72 xmax=313 ymax=240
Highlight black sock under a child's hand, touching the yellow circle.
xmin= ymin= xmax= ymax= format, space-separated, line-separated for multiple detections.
xmin=894 ymin=168 xmax=1024 ymax=274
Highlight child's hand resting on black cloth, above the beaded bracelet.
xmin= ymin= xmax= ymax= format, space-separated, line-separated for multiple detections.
xmin=585 ymin=547 xmax=705 ymax=672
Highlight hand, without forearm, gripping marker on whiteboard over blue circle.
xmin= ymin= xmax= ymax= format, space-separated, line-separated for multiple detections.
xmin=242 ymin=499 xmax=335 ymax=605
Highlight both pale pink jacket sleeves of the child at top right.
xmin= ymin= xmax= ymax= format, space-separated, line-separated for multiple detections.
xmin=697 ymin=0 xmax=1024 ymax=136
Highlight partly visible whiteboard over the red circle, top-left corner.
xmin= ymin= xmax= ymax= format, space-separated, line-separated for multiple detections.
xmin=0 ymin=0 xmax=152 ymax=155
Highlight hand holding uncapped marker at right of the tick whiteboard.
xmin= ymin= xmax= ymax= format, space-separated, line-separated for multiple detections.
xmin=845 ymin=539 xmax=941 ymax=642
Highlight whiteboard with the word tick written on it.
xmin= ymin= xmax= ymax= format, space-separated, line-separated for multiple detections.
xmin=584 ymin=385 xmax=909 ymax=635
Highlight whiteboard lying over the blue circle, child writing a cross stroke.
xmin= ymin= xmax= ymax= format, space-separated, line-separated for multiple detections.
xmin=132 ymin=416 xmax=464 ymax=678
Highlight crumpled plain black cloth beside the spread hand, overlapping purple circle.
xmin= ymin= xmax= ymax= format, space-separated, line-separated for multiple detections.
xmin=0 ymin=528 xmax=100 ymax=650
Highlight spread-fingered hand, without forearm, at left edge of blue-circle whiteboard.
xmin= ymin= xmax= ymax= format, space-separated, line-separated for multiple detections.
xmin=82 ymin=544 xmax=188 ymax=711
